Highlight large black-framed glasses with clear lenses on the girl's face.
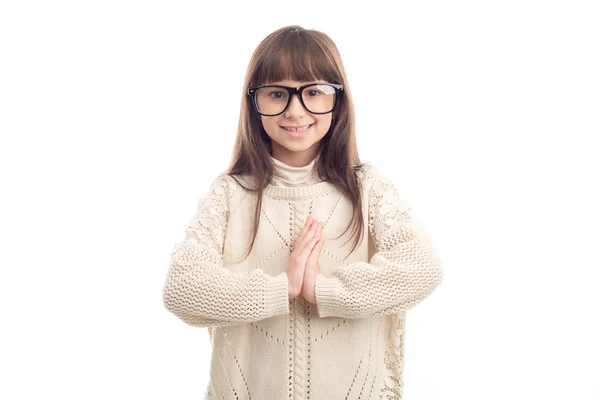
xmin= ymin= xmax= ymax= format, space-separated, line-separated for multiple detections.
xmin=248 ymin=83 xmax=344 ymax=117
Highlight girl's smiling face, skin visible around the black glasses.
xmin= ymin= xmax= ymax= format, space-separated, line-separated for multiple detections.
xmin=260 ymin=80 xmax=332 ymax=167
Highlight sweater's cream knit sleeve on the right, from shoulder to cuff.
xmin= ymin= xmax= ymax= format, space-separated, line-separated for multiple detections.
xmin=315 ymin=164 xmax=443 ymax=318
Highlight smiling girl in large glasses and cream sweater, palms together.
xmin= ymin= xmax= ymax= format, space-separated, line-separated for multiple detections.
xmin=163 ymin=26 xmax=442 ymax=400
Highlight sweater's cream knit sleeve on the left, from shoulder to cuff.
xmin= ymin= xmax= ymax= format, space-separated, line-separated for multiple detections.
xmin=163 ymin=175 xmax=290 ymax=327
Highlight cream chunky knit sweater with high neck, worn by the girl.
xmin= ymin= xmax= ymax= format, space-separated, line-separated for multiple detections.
xmin=163 ymin=158 xmax=442 ymax=400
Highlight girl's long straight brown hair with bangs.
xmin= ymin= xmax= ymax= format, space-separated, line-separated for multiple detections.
xmin=224 ymin=25 xmax=364 ymax=258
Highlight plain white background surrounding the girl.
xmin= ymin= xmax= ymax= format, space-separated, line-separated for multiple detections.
xmin=0 ymin=0 xmax=600 ymax=400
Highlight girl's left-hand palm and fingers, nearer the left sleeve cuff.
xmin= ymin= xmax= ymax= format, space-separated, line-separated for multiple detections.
xmin=285 ymin=215 xmax=323 ymax=299
